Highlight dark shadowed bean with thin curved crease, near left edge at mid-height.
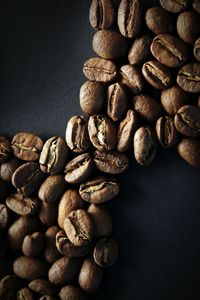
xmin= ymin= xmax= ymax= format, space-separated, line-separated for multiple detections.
xmin=12 ymin=162 xmax=44 ymax=196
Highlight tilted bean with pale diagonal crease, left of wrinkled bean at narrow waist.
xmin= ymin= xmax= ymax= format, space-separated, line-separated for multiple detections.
xmin=64 ymin=153 xmax=93 ymax=184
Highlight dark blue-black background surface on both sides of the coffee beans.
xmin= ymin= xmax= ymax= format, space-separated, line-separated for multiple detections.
xmin=0 ymin=0 xmax=200 ymax=300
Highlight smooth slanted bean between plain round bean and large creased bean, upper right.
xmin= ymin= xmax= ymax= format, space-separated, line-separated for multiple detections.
xmin=128 ymin=34 xmax=152 ymax=65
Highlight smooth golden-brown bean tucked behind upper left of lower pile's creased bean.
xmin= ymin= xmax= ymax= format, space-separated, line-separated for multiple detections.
xmin=58 ymin=189 xmax=84 ymax=228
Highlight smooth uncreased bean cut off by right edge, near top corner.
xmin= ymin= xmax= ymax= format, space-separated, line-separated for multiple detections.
xmin=176 ymin=10 xmax=200 ymax=45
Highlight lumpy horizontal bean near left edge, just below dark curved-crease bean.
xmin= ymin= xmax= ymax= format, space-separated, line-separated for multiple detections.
xmin=6 ymin=193 xmax=40 ymax=216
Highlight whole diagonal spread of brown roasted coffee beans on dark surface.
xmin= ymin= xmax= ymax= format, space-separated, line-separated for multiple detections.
xmin=0 ymin=0 xmax=200 ymax=300
